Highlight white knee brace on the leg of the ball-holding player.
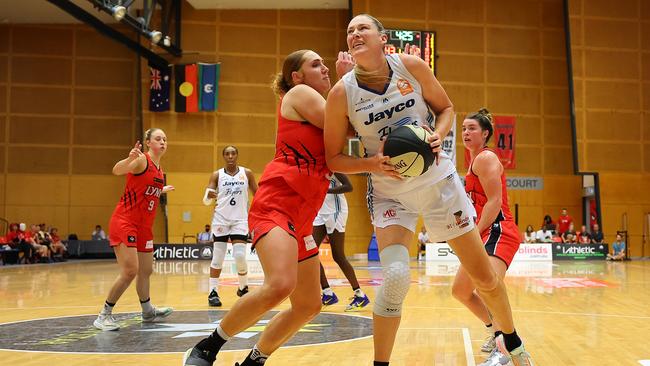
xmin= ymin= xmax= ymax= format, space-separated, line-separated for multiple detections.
xmin=373 ymin=244 xmax=411 ymax=317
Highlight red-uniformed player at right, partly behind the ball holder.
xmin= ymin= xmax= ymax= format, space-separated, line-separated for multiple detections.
xmin=452 ymin=108 xmax=521 ymax=366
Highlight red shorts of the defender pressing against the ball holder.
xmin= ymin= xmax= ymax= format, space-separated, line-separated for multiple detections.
xmin=248 ymin=178 xmax=329 ymax=262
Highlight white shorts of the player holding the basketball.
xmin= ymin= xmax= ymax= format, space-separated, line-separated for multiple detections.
xmin=368 ymin=173 xmax=476 ymax=242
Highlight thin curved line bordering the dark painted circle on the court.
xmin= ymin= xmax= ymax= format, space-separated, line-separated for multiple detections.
xmin=0 ymin=310 xmax=370 ymax=354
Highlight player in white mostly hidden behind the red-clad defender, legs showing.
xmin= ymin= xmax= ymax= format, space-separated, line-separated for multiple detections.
xmin=312 ymin=173 xmax=370 ymax=311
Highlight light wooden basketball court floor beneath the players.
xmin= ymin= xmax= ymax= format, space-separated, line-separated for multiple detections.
xmin=0 ymin=261 xmax=650 ymax=366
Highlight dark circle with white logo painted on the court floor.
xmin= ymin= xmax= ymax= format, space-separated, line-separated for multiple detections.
xmin=0 ymin=310 xmax=372 ymax=357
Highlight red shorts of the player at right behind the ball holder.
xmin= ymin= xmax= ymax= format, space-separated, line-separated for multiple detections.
xmin=481 ymin=221 xmax=521 ymax=267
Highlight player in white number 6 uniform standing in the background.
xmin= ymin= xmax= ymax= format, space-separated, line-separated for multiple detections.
xmin=203 ymin=146 xmax=257 ymax=306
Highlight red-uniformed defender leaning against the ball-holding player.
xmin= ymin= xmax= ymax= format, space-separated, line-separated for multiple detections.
xmin=183 ymin=50 xmax=350 ymax=366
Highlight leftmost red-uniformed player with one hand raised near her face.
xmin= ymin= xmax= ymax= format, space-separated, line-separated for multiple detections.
xmin=93 ymin=128 xmax=174 ymax=330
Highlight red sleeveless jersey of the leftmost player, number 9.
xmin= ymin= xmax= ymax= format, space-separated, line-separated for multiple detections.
xmin=113 ymin=153 xmax=165 ymax=226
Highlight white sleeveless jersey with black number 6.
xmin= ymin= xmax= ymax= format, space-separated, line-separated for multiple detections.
xmin=213 ymin=166 xmax=248 ymax=222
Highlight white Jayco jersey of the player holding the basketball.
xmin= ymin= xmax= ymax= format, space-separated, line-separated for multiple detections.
xmin=343 ymin=54 xmax=456 ymax=194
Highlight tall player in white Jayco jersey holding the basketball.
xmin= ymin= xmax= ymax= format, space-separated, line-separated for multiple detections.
xmin=324 ymin=14 xmax=532 ymax=366
